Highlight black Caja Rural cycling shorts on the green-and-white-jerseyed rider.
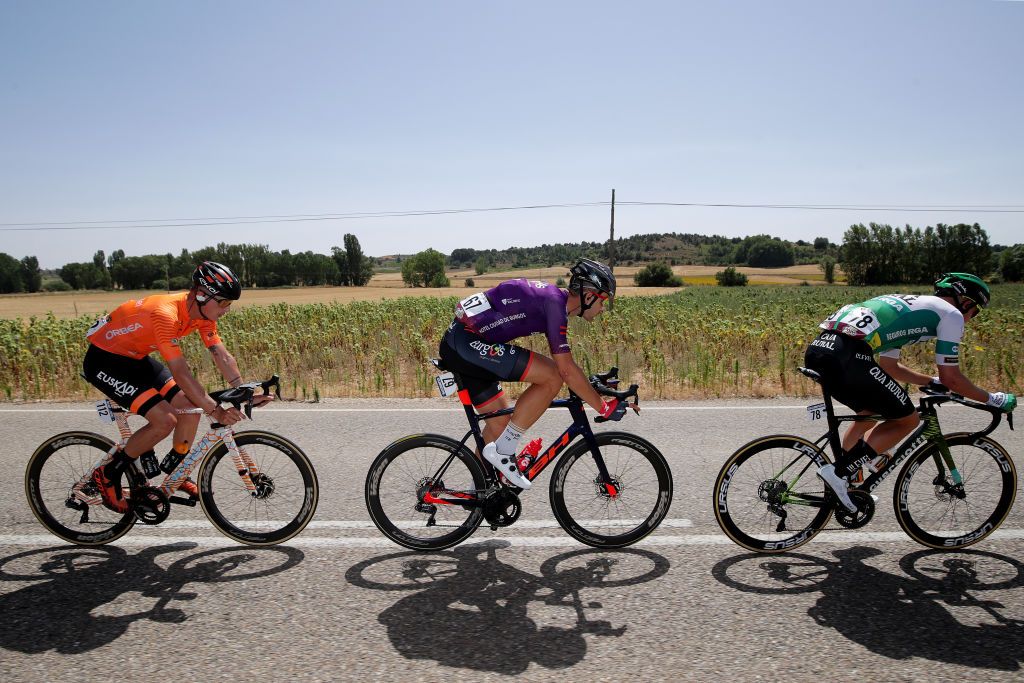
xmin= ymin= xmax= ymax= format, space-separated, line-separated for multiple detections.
xmin=804 ymin=332 xmax=914 ymax=419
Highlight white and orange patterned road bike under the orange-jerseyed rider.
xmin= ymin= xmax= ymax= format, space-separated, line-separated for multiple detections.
xmin=25 ymin=375 xmax=319 ymax=546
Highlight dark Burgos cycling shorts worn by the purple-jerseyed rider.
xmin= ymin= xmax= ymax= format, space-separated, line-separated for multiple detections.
xmin=438 ymin=321 xmax=534 ymax=408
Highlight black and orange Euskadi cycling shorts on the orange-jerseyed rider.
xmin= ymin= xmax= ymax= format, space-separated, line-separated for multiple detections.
xmin=82 ymin=344 xmax=181 ymax=416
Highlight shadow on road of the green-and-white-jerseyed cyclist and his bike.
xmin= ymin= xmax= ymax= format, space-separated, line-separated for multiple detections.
xmin=712 ymin=547 xmax=1024 ymax=671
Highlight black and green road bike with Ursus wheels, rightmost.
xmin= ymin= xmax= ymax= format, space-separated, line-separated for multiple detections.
xmin=714 ymin=368 xmax=1017 ymax=553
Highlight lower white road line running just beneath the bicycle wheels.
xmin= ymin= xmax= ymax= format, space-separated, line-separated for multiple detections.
xmin=0 ymin=529 xmax=1024 ymax=549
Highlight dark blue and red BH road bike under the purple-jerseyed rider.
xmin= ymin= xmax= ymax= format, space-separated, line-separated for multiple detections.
xmin=366 ymin=360 xmax=672 ymax=550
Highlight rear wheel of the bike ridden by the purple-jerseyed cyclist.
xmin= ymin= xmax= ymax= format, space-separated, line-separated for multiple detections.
xmin=365 ymin=434 xmax=487 ymax=550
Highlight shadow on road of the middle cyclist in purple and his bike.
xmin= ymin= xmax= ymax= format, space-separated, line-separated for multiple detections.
xmin=345 ymin=541 xmax=670 ymax=674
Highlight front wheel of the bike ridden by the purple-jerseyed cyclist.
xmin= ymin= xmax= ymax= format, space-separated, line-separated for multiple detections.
xmin=550 ymin=432 xmax=672 ymax=548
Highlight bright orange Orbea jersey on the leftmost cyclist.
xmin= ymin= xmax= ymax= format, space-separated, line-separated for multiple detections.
xmin=86 ymin=292 xmax=221 ymax=360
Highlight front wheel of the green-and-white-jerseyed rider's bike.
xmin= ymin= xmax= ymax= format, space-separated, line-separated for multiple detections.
xmin=893 ymin=433 xmax=1017 ymax=550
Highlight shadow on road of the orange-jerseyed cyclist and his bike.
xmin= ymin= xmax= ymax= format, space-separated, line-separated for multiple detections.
xmin=0 ymin=543 xmax=304 ymax=654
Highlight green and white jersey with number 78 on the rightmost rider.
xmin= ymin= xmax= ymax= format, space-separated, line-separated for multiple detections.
xmin=818 ymin=294 xmax=964 ymax=366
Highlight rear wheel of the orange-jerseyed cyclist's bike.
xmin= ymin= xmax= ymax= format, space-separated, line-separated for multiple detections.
xmin=25 ymin=431 xmax=135 ymax=546
